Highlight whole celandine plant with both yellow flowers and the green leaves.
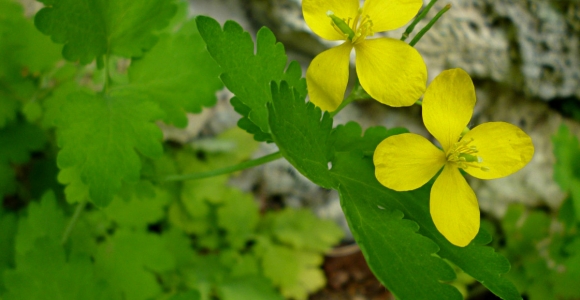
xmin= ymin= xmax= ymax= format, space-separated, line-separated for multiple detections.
xmin=0 ymin=0 xmax=534 ymax=300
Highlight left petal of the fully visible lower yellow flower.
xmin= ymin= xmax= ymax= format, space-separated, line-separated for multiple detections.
xmin=373 ymin=133 xmax=446 ymax=191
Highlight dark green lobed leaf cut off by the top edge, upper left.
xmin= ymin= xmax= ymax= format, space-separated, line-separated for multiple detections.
xmin=34 ymin=0 xmax=177 ymax=65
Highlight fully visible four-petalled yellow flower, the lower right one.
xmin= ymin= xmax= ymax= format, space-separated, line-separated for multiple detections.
xmin=373 ymin=69 xmax=534 ymax=247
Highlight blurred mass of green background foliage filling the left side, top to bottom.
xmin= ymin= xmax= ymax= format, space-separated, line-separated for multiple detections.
xmin=0 ymin=0 xmax=343 ymax=300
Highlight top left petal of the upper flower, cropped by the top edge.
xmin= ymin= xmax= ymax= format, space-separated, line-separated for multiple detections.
xmin=302 ymin=0 xmax=359 ymax=41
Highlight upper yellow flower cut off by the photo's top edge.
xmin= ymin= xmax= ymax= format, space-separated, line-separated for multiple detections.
xmin=302 ymin=0 xmax=427 ymax=111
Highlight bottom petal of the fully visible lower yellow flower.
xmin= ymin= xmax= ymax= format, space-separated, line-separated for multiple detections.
xmin=429 ymin=164 xmax=479 ymax=247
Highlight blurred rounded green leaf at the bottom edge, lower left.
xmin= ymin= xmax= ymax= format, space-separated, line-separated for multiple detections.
xmin=95 ymin=230 xmax=175 ymax=300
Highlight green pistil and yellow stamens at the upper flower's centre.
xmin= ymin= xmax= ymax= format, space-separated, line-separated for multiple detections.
xmin=326 ymin=9 xmax=375 ymax=44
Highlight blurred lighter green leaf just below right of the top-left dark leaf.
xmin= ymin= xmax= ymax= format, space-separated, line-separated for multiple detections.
xmin=128 ymin=20 xmax=223 ymax=127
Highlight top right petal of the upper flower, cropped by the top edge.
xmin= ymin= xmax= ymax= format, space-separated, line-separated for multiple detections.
xmin=362 ymin=0 xmax=423 ymax=32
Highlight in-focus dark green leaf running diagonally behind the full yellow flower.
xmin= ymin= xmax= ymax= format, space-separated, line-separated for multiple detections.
xmin=270 ymin=77 xmax=520 ymax=299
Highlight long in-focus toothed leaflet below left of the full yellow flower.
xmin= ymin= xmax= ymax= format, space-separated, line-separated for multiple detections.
xmin=333 ymin=153 xmax=462 ymax=299
